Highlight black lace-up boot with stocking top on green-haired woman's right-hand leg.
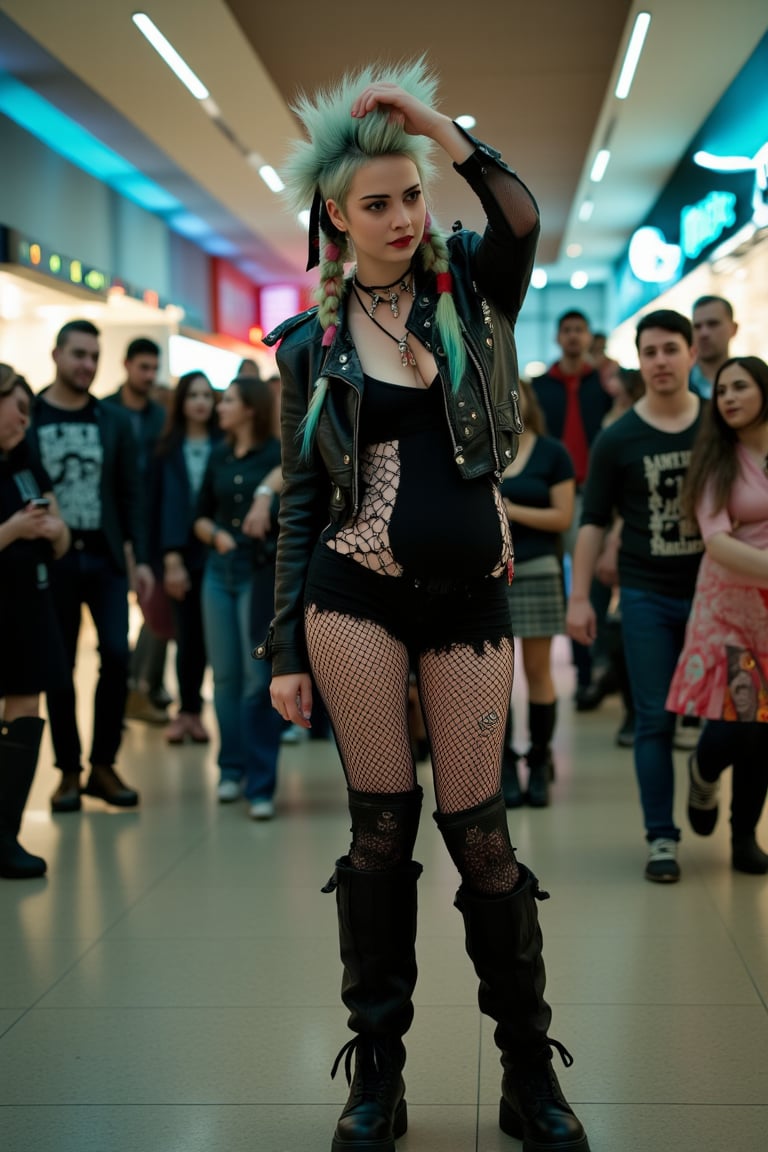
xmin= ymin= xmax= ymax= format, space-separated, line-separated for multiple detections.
xmin=438 ymin=797 xmax=590 ymax=1152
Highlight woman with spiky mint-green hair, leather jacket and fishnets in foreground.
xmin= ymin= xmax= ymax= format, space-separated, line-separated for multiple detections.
xmin=260 ymin=61 xmax=588 ymax=1152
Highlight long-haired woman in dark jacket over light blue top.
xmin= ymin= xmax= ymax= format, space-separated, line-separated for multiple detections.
xmin=157 ymin=371 xmax=221 ymax=744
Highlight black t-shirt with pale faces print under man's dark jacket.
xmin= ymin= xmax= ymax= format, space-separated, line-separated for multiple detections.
xmin=35 ymin=396 xmax=104 ymax=532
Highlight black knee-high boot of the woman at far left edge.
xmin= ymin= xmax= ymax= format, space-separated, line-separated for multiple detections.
xmin=0 ymin=717 xmax=46 ymax=880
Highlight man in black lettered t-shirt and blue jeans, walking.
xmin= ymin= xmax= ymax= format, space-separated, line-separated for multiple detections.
xmin=568 ymin=310 xmax=704 ymax=882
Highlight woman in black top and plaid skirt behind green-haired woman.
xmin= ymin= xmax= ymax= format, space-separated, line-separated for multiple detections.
xmin=501 ymin=380 xmax=576 ymax=808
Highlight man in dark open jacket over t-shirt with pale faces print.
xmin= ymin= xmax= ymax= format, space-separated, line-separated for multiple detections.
xmin=28 ymin=320 xmax=153 ymax=812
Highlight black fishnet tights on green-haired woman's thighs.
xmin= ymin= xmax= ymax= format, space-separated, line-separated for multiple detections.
xmin=306 ymin=605 xmax=514 ymax=812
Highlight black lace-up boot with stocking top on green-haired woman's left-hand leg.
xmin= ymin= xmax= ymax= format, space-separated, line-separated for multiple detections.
xmin=325 ymin=789 xmax=421 ymax=1152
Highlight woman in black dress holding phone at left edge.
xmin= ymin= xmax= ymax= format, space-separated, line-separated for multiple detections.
xmin=0 ymin=364 xmax=69 ymax=880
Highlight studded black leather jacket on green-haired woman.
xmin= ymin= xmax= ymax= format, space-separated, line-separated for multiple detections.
xmin=253 ymin=134 xmax=539 ymax=675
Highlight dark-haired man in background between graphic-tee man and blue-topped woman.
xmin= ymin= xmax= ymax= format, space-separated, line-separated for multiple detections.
xmin=105 ymin=336 xmax=170 ymax=723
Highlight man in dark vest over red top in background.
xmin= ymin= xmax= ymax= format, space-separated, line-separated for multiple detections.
xmin=531 ymin=309 xmax=611 ymax=712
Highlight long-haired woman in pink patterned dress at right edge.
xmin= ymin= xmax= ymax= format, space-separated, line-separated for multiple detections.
xmin=667 ymin=356 xmax=768 ymax=874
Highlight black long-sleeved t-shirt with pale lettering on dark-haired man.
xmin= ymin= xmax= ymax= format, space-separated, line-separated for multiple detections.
xmin=581 ymin=410 xmax=704 ymax=599
